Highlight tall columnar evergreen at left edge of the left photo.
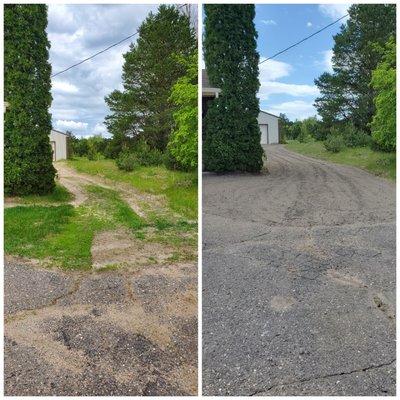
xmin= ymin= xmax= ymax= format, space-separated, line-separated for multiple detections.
xmin=4 ymin=4 xmax=55 ymax=195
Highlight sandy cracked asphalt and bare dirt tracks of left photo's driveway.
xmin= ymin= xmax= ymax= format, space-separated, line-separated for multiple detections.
xmin=4 ymin=164 xmax=197 ymax=396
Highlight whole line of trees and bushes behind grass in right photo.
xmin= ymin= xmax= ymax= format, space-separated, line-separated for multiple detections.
xmin=280 ymin=4 xmax=396 ymax=152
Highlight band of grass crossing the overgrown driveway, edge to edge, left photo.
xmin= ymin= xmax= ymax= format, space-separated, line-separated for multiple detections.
xmin=4 ymin=185 xmax=197 ymax=270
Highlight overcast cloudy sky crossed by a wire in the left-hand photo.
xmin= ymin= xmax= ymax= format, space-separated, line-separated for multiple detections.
xmin=47 ymin=4 xmax=157 ymax=136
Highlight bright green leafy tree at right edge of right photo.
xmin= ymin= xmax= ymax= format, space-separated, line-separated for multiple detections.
xmin=371 ymin=37 xmax=396 ymax=151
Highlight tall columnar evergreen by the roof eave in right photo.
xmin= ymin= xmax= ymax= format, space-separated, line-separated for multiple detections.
xmin=203 ymin=4 xmax=263 ymax=172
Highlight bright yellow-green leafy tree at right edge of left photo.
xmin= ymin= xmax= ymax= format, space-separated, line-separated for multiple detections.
xmin=168 ymin=51 xmax=198 ymax=170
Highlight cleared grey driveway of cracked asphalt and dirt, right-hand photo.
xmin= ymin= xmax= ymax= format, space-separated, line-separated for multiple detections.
xmin=202 ymin=145 xmax=396 ymax=396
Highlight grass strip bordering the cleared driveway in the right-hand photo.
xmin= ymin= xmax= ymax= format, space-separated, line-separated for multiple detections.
xmin=286 ymin=140 xmax=396 ymax=180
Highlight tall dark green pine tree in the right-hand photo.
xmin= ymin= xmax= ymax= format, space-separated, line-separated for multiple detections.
xmin=315 ymin=4 xmax=396 ymax=130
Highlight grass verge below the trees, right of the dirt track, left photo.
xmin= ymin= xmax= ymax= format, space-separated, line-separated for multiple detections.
xmin=68 ymin=158 xmax=197 ymax=220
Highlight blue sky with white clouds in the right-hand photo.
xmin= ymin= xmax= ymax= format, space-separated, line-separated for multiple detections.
xmin=255 ymin=4 xmax=349 ymax=119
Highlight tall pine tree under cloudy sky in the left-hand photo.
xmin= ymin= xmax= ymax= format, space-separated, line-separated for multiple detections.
xmin=105 ymin=5 xmax=196 ymax=154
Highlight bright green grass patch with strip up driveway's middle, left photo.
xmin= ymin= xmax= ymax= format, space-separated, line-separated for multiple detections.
xmin=4 ymin=186 xmax=144 ymax=269
